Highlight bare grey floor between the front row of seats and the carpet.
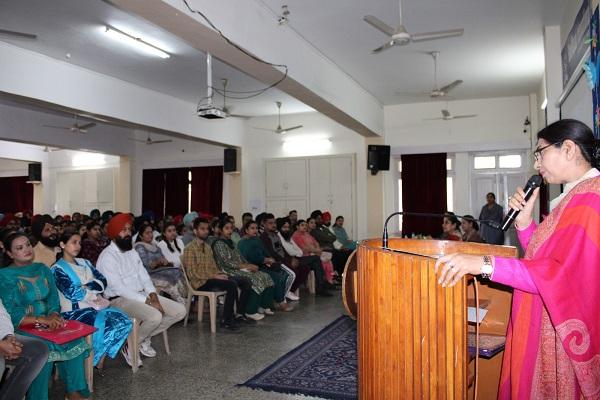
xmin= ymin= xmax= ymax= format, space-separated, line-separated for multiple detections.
xmin=51 ymin=291 xmax=344 ymax=400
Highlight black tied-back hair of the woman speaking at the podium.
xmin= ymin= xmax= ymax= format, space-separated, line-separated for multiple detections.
xmin=538 ymin=119 xmax=600 ymax=168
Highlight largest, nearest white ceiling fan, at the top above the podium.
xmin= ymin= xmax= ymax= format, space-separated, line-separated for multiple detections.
xmin=363 ymin=0 xmax=464 ymax=53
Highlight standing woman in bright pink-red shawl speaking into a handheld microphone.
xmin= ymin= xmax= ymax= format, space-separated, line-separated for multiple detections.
xmin=435 ymin=120 xmax=600 ymax=399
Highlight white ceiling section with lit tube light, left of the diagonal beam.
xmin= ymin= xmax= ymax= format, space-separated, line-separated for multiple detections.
xmin=0 ymin=0 xmax=312 ymax=116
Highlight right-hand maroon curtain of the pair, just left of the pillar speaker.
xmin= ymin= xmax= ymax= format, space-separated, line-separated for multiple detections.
xmin=191 ymin=167 xmax=223 ymax=215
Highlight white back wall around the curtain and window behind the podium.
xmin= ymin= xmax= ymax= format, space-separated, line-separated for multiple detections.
xmin=384 ymin=96 xmax=531 ymax=231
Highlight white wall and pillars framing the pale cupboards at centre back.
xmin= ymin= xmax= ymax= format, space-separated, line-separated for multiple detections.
xmin=241 ymin=112 xmax=369 ymax=238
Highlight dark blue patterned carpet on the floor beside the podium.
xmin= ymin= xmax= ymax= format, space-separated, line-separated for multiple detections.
xmin=243 ymin=316 xmax=358 ymax=400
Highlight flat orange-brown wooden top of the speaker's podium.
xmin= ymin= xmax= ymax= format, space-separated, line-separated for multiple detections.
xmin=359 ymin=238 xmax=518 ymax=258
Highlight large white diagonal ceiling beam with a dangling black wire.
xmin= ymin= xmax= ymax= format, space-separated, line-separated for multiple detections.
xmin=110 ymin=0 xmax=383 ymax=137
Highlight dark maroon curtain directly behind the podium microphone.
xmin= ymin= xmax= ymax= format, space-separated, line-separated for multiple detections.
xmin=401 ymin=153 xmax=447 ymax=238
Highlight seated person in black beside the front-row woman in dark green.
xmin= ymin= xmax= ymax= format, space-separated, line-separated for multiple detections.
xmin=260 ymin=214 xmax=310 ymax=301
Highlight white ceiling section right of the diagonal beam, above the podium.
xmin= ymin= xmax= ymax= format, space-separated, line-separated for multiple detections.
xmin=255 ymin=0 xmax=566 ymax=105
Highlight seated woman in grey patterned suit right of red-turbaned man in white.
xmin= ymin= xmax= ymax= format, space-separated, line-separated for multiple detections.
xmin=135 ymin=224 xmax=186 ymax=304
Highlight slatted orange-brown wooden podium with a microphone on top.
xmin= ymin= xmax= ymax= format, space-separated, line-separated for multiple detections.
xmin=343 ymin=239 xmax=517 ymax=400
